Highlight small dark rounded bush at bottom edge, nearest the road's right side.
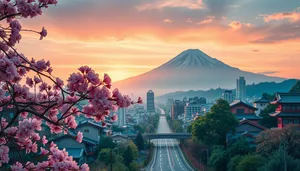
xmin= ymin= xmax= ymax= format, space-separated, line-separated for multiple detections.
xmin=208 ymin=146 xmax=227 ymax=171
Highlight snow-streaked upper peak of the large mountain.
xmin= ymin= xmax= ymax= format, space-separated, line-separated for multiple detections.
xmin=160 ymin=49 xmax=230 ymax=69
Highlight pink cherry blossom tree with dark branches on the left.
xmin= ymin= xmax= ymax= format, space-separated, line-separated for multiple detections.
xmin=0 ymin=0 xmax=142 ymax=171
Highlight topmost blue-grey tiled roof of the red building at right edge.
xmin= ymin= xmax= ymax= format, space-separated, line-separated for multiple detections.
xmin=271 ymin=93 xmax=300 ymax=104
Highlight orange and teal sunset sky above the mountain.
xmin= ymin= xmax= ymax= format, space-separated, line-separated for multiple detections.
xmin=18 ymin=0 xmax=300 ymax=81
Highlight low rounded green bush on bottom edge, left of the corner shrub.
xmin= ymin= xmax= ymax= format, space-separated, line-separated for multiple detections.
xmin=236 ymin=155 xmax=266 ymax=171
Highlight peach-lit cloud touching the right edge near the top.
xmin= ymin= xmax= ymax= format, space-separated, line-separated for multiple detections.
xmin=260 ymin=12 xmax=300 ymax=23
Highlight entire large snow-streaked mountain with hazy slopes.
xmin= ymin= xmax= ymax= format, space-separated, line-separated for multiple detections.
xmin=113 ymin=49 xmax=284 ymax=95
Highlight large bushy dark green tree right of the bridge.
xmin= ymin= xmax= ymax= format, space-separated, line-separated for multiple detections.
xmin=192 ymin=99 xmax=238 ymax=146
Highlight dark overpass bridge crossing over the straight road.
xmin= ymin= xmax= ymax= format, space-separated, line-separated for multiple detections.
xmin=126 ymin=133 xmax=192 ymax=140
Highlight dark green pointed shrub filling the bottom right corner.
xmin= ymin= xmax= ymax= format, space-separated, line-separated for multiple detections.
xmin=259 ymin=148 xmax=300 ymax=171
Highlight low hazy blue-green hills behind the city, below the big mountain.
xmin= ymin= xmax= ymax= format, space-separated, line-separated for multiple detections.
xmin=156 ymin=79 xmax=297 ymax=103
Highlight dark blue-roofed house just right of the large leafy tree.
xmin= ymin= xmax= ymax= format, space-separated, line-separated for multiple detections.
xmin=226 ymin=119 xmax=268 ymax=146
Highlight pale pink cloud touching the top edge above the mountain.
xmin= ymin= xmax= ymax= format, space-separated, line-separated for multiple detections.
xmin=136 ymin=0 xmax=204 ymax=11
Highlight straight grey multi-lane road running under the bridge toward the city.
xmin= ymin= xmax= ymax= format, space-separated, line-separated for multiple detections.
xmin=146 ymin=108 xmax=193 ymax=171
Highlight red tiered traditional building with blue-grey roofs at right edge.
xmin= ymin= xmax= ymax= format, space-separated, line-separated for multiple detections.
xmin=270 ymin=93 xmax=300 ymax=128
